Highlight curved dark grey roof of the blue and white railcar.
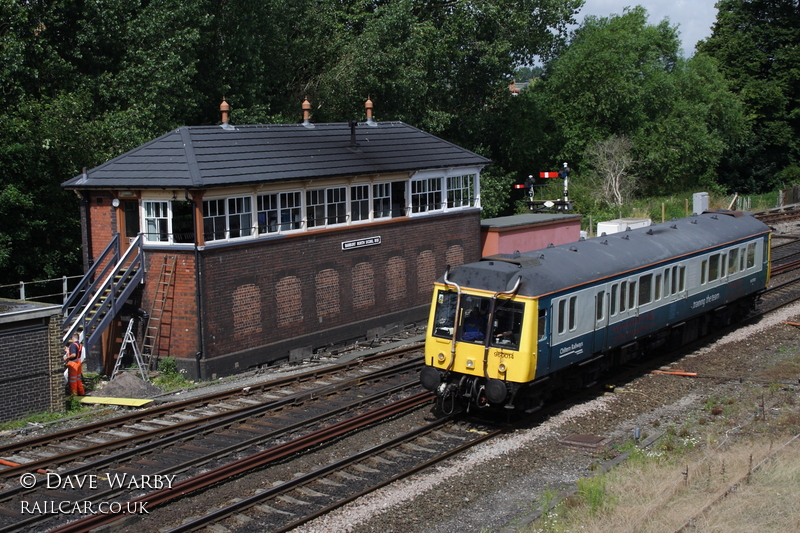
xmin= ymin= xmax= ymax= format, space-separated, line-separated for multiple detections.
xmin=439 ymin=211 xmax=770 ymax=296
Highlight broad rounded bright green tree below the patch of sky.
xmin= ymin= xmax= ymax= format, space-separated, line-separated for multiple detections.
xmin=534 ymin=7 xmax=747 ymax=192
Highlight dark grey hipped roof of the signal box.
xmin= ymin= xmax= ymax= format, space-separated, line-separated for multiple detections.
xmin=62 ymin=122 xmax=490 ymax=189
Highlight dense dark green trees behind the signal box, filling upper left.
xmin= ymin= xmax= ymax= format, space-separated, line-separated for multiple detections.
xmin=0 ymin=0 xmax=582 ymax=284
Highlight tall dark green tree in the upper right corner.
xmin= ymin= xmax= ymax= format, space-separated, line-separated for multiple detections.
xmin=697 ymin=0 xmax=800 ymax=192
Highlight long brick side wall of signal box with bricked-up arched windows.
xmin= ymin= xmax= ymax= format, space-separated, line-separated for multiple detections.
xmin=191 ymin=211 xmax=480 ymax=377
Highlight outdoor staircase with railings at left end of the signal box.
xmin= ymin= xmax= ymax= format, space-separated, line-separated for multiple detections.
xmin=62 ymin=234 xmax=144 ymax=350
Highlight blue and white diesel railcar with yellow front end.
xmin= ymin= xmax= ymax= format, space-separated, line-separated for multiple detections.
xmin=420 ymin=212 xmax=770 ymax=409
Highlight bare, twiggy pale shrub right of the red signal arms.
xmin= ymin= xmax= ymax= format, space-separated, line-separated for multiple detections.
xmin=586 ymin=136 xmax=638 ymax=206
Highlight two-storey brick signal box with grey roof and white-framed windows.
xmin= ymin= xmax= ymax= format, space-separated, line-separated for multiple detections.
xmin=63 ymin=102 xmax=489 ymax=379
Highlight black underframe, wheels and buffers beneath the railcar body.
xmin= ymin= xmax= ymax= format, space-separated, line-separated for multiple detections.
xmin=420 ymin=294 xmax=759 ymax=413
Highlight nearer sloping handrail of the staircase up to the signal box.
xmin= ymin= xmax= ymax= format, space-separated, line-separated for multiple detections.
xmin=63 ymin=233 xmax=142 ymax=350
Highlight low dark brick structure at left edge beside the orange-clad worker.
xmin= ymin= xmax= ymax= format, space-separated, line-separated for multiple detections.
xmin=0 ymin=309 xmax=64 ymax=422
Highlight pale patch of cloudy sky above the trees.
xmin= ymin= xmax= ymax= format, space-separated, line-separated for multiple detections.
xmin=577 ymin=0 xmax=717 ymax=57
